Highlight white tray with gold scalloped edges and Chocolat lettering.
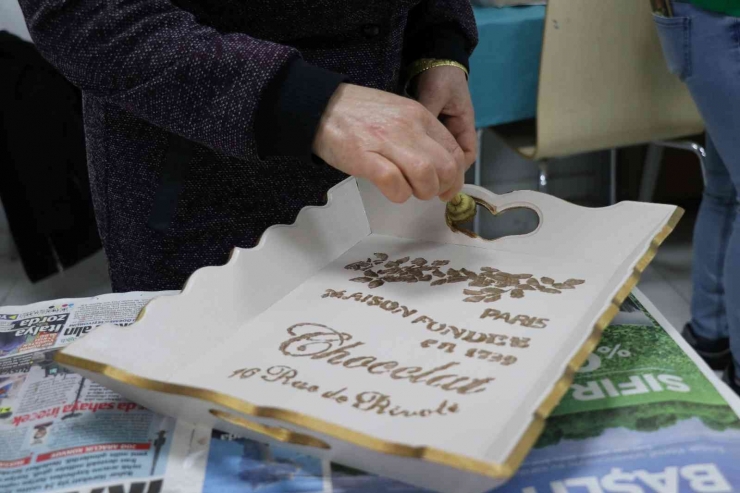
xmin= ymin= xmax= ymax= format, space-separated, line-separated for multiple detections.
xmin=58 ymin=179 xmax=682 ymax=493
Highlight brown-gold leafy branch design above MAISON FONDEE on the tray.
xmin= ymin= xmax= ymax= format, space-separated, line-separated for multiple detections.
xmin=345 ymin=253 xmax=586 ymax=303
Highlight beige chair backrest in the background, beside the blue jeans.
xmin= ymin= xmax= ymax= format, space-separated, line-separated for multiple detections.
xmin=522 ymin=0 xmax=704 ymax=159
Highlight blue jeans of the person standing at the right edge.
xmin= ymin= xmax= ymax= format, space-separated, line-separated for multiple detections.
xmin=655 ymin=1 xmax=740 ymax=368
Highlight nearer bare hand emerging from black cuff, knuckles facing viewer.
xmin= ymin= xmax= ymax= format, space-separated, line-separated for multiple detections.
xmin=313 ymin=84 xmax=467 ymax=203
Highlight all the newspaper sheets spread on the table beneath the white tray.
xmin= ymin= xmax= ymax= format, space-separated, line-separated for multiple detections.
xmin=0 ymin=291 xmax=740 ymax=493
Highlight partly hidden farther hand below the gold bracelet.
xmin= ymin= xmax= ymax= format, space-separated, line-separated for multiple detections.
xmin=411 ymin=66 xmax=478 ymax=170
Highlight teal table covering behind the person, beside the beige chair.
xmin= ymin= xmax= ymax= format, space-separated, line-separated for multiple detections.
xmin=470 ymin=6 xmax=545 ymax=128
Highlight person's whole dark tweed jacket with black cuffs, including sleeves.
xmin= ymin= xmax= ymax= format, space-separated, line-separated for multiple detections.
xmin=20 ymin=0 xmax=477 ymax=291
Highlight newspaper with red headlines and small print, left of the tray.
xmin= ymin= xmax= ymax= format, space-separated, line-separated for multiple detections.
xmin=0 ymin=292 xmax=210 ymax=493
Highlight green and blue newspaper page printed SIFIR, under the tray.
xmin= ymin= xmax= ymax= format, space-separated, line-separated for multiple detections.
xmin=203 ymin=291 xmax=740 ymax=493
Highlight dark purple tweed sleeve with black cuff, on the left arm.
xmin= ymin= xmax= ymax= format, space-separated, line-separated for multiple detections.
xmin=20 ymin=0 xmax=344 ymax=160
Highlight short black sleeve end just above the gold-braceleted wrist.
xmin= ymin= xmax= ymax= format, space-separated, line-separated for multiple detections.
xmin=404 ymin=0 xmax=478 ymax=69
